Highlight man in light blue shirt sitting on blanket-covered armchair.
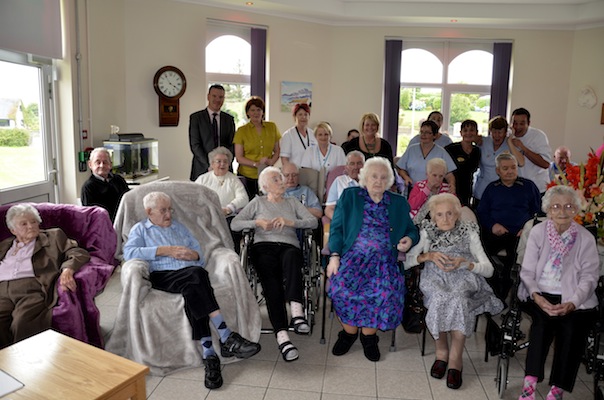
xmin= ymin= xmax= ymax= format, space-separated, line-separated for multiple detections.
xmin=124 ymin=192 xmax=260 ymax=389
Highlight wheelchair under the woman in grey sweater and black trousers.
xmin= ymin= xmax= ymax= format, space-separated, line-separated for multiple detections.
xmin=240 ymin=229 xmax=323 ymax=335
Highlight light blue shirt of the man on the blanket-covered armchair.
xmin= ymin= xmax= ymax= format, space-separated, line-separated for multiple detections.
xmin=124 ymin=219 xmax=204 ymax=272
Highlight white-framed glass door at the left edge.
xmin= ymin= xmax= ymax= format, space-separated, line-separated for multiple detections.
xmin=0 ymin=50 xmax=57 ymax=204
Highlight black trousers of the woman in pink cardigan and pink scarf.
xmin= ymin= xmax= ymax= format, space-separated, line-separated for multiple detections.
xmin=526 ymin=293 xmax=597 ymax=392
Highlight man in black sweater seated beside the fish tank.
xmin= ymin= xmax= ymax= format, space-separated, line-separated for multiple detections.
xmin=81 ymin=147 xmax=130 ymax=221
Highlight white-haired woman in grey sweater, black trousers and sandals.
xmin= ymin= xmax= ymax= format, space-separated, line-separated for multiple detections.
xmin=231 ymin=167 xmax=317 ymax=362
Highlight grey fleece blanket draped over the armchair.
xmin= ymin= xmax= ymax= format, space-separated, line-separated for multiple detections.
xmin=106 ymin=181 xmax=261 ymax=376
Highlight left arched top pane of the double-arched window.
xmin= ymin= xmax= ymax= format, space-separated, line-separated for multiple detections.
xmin=401 ymin=49 xmax=443 ymax=83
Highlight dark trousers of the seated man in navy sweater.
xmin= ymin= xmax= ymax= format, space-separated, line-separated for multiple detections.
xmin=482 ymin=231 xmax=519 ymax=303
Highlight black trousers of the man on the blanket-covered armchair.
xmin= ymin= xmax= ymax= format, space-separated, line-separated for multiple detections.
xmin=150 ymin=266 xmax=220 ymax=340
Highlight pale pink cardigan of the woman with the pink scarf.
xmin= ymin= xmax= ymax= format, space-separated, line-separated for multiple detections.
xmin=518 ymin=222 xmax=600 ymax=309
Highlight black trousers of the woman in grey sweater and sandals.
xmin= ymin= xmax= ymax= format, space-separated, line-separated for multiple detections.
xmin=251 ymin=242 xmax=303 ymax=332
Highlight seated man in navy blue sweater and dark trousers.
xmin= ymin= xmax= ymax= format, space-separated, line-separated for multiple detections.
xmin=477 ymin=153 xmax=541 ymax=301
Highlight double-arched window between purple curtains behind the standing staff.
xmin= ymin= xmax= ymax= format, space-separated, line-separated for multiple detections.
xmin=397 ymin=40 xmax=493 ymax=155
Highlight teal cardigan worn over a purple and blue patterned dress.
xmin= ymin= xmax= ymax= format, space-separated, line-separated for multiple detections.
xmin=329 ymin=187 xmax=419 ymax=258
